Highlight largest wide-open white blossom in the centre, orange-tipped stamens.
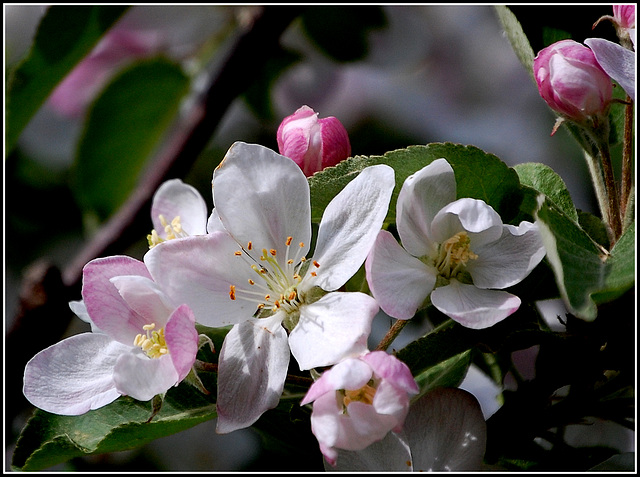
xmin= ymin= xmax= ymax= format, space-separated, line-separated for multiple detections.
xmin=144 ymin=142 xmax=395 ymax=433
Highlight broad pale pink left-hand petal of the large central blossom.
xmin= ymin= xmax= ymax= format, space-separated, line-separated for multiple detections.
xmin=144 ymin=232 xmax=257 ymax=327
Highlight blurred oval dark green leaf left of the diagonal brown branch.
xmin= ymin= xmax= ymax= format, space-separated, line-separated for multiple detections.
xmin=73 ymin=58 xmax=189 ymax=220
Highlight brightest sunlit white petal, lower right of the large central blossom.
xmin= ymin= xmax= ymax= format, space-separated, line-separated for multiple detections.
xmin=289 ymin=292 xmax=379 ymax=370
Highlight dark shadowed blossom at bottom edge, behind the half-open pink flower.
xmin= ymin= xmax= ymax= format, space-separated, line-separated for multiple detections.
xmin=325 ymin=388 xmax=487 ymax=473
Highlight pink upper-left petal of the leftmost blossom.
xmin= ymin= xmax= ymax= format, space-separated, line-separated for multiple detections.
xmin=82 ymin=255 xmax=151 ymax=344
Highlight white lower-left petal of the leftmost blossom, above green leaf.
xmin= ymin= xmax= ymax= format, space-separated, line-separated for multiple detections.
xmin=23 ymin=333 xmax=126 ymax=416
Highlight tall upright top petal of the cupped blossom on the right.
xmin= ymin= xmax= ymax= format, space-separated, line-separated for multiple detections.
xmin=396 ymin=159 xmax=456 ymax=257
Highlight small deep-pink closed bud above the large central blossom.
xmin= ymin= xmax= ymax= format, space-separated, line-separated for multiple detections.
xmin=277 ymin=106 xmax=351 ymax=177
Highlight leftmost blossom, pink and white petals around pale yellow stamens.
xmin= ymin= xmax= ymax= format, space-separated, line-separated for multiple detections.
xmin=23 ymin=256 xmax=199 ymax=415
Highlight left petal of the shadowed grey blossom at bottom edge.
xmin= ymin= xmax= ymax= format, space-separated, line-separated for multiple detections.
xmin=324 ymin=432 xmax=413 ymax=473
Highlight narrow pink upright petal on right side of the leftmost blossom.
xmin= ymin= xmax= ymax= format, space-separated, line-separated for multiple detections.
xmin=164 ymin=305 xmax=199 ymax=381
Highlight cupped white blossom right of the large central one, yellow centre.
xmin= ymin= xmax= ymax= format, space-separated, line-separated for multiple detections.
xmin=365 ymin=159 xmax=545 ymax=329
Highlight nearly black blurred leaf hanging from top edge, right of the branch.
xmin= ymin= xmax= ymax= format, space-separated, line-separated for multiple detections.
xmin=302 ymin=5 xmax=387 ymax=61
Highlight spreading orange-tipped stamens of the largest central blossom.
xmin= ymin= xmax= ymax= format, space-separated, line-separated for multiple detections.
xmin=229 ymin=237 xmax=320 ymax=329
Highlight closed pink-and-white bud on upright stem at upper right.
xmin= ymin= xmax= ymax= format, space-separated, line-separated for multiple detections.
xmin=533 ymin=40 xmax=613 ymax=123
